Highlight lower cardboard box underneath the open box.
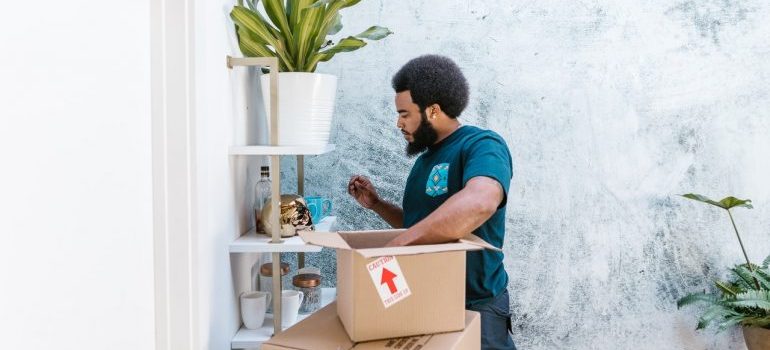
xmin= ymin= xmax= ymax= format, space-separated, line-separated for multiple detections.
xmin=262 ymin=303 xmax=481 ymax=350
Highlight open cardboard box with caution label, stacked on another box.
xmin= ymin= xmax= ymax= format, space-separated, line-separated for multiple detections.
xmin=300 ymin=230 xmax=497 ymax=342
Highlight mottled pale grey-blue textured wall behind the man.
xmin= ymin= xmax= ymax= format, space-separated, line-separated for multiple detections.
xmin=284 ymin=0 xmax=770 ymax=349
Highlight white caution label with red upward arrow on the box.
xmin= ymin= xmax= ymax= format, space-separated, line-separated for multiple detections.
xmin=366 ymin=256 xmax=412 ymax=309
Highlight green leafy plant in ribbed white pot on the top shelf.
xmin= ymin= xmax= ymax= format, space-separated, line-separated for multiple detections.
xmin=230 ymin=0 xmax=392 ymax=145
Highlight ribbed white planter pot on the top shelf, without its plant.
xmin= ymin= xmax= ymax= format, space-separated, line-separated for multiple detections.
xmin=261 ymin=72 xmax=337 ymax=146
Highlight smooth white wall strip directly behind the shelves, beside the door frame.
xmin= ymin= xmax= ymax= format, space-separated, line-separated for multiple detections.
xmin=195 ymin=0 xmax=267 ymax=350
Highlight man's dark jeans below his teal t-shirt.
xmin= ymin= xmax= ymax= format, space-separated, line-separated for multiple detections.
xmin=468 ymin=289 xmax=516 ymax=350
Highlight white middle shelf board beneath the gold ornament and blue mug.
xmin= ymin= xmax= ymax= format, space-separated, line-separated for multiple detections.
xmin=230 ymin=216 xmax=337 ymax=253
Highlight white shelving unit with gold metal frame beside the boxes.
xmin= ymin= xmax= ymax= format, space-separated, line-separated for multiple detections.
xmin=227 ymin=56 xmax=337 ymax=349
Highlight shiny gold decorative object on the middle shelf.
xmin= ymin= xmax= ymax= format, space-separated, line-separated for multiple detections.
xmin=262 ymin=194 xmax=313 ymax=237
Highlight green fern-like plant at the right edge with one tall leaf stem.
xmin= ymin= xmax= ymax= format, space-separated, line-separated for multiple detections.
xmin=677 ymin=193 xmax=770 ymax=350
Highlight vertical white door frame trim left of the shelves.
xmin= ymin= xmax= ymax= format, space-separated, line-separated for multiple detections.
xmin=150 ymin=0 xmax=199 ymax=350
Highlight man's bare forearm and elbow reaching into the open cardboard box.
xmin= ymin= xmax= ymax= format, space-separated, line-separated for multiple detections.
xmin=380 ymin=176 xmax=504 ymax=247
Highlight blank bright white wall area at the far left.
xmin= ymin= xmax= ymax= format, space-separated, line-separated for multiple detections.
xmin=0 ymin=0 xmax=154 ymax=350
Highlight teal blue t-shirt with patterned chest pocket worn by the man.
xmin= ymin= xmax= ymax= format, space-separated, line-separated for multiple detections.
xmin=402 ymin=126 xmax=513 ymax=306
